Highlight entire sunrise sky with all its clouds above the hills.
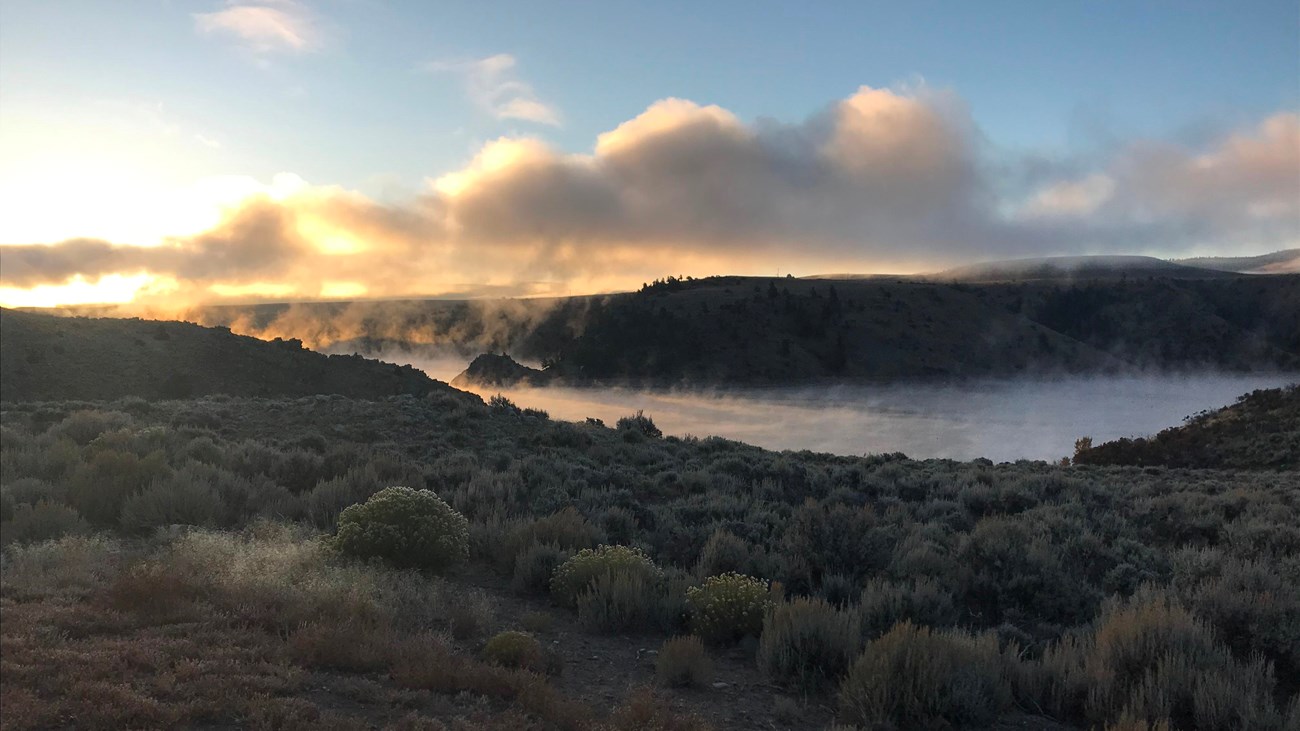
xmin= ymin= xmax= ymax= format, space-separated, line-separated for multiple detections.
xmin=0 ymin=0 xmax=1300 ymax=306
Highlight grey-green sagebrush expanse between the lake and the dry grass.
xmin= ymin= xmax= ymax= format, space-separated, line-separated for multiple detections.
xmin=0 ymin=398 xmax=1300 ymax=728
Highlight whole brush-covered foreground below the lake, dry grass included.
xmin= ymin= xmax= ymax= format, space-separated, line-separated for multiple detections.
xmin=0 ymin=385 xmax=1300 ymax=730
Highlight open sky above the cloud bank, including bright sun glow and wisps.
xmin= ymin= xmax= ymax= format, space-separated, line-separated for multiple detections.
xmin=0 ymin=0 xmax=1300 ymax=301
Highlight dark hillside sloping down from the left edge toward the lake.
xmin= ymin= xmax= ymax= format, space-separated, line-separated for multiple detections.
xmin=0 ymin=310 xmax=452 ymax=401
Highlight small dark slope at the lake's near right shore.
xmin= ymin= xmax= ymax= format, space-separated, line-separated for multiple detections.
xmin=1074 ymin=385 xmax=1300 ymax=471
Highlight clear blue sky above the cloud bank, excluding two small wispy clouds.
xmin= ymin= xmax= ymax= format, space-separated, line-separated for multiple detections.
xmin=0 ymin=0 xmax=1300 ymax=187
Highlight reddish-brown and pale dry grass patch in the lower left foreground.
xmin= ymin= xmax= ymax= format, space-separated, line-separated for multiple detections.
xmin=0 ymin=525 xmax=712 ymax=731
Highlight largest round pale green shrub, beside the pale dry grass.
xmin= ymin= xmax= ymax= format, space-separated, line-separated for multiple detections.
xmin=334 ymin=488 xmax=469 ymax=571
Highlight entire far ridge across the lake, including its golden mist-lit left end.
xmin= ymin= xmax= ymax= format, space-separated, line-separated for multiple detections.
xmin=53 ymin=260 xmax=1300 ymax=386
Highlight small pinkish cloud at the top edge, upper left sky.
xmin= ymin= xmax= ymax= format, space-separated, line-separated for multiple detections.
xmin=194 ymin=0 xmax=324 ymax=55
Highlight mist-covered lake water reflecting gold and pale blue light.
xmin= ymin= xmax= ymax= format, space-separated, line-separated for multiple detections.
xmin=400 ymin=358 xmax=1296 ymax=462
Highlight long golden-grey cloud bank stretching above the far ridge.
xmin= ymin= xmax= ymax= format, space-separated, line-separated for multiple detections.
xmin=0 ymin=86 xmax=1300 ymax=305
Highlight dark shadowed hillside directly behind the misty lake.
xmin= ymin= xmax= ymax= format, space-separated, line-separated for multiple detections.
xmin=470 ymin=276 xmax=1300 ymax=385
